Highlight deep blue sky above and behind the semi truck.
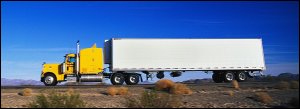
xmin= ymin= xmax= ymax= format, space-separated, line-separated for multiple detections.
xmin=1 ymin=1 xmax=299 ymax=81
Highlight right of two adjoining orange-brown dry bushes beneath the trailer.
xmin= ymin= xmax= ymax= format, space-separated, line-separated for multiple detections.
xmin=170 ymin=83 xmax=192 ymax=95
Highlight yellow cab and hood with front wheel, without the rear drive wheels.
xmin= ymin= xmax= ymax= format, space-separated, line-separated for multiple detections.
xmin=41 ymin=42 xmax=103 ymax=86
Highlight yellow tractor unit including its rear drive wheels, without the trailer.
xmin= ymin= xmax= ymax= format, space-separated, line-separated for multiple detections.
xmin=41 ymin=41 xmax=141 ymax=86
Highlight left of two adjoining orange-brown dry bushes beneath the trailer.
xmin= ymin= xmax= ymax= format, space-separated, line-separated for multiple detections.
xmin=155 ymin=79 xmax=175 ymax=91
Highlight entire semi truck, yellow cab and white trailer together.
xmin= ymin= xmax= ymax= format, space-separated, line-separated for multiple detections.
xmin=41 ymin=38 xmax=266 ymax=85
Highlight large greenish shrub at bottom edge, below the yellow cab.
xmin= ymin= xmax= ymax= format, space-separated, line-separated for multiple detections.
xmin=29 ymin=91 xmax=86 ymax=108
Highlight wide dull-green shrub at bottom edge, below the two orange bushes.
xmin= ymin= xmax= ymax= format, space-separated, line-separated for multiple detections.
xmin=126 ymin=91 xmax=182 ymax=108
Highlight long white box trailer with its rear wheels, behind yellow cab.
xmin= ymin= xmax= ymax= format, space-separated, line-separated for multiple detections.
xmin=104 ymin=38 xmax=266 ymax=82
